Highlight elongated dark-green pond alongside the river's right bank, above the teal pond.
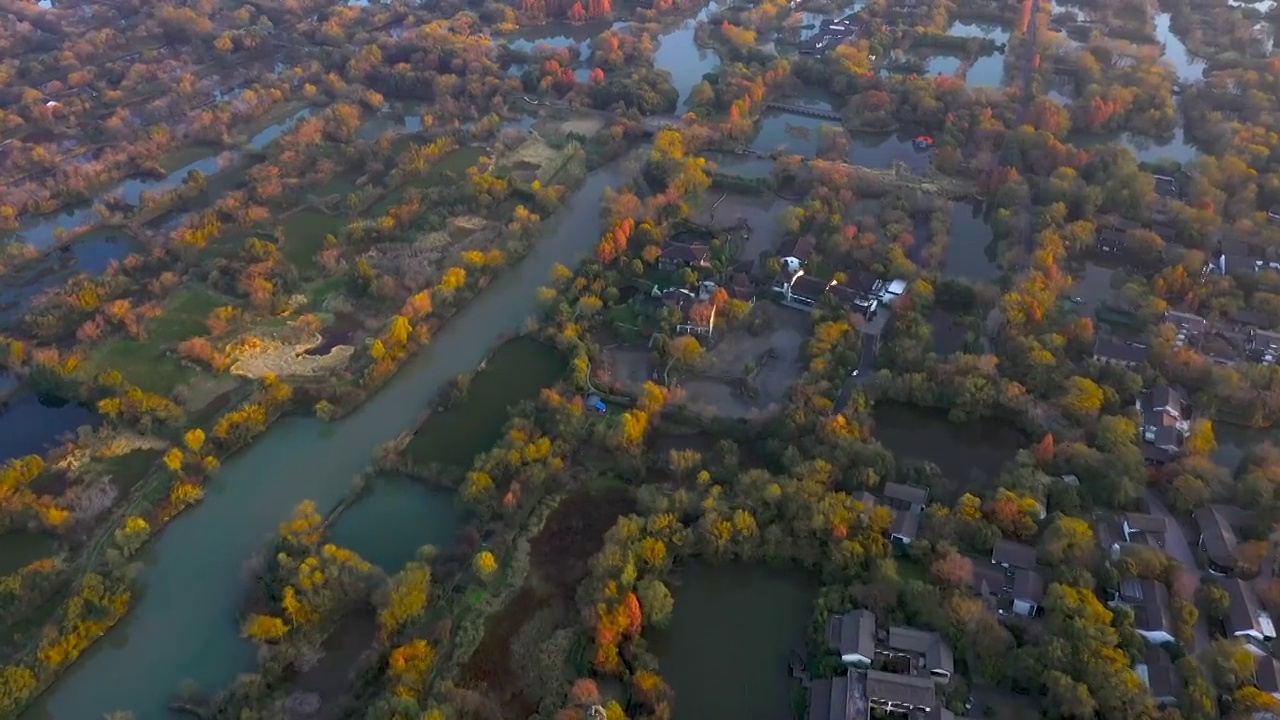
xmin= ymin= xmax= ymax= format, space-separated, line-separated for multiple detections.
xmin=406 ymin=337 xmax=567 ymax=468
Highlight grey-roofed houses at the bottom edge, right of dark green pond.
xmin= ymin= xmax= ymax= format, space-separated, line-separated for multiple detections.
xmin=809 ymin=610 xmax=956 ymax=720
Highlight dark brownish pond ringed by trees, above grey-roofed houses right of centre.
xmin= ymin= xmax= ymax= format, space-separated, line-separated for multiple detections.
xmin=873 ymin=402 xmax=1025 ymax=500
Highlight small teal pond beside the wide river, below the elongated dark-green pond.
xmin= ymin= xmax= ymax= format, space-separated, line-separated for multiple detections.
xmin=328 ymin=477 xmax=462 ymax=575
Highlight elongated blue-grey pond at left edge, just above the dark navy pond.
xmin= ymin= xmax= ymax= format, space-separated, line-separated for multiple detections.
xmin=0 ymin=229 xmax=140 ymax=323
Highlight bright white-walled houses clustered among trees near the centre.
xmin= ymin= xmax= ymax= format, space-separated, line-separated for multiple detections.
xmin=773 ymin=236 xmax=906 ymax=318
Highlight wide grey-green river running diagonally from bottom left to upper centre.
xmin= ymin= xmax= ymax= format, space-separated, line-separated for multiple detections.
xmin=27 ymin=155 xmax=623 ymax=720
